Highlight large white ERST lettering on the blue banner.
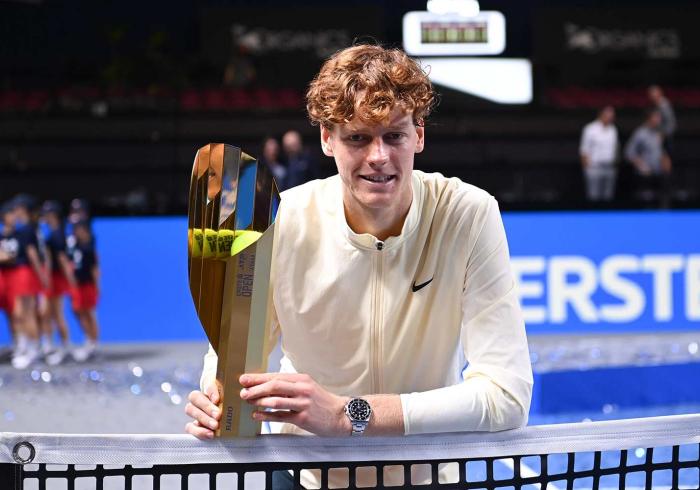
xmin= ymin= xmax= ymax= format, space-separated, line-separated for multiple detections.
xmin=511 ymin=254 xmax=700 ymax=325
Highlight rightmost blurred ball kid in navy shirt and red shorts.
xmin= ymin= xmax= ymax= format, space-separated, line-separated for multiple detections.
xmin=70 ymin=220 xmax=100 ymax=362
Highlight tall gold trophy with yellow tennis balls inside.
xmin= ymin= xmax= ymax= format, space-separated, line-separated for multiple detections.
xmin=188 ymin=143 xmax=280 ymax=437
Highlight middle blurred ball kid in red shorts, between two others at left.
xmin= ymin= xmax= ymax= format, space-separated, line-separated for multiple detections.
xmin=41 ymin=201 xmax=77 ymax=366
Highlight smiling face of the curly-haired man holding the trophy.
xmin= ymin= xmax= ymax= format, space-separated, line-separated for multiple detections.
xmin=321 ymin=107 xmax=424 ymax=210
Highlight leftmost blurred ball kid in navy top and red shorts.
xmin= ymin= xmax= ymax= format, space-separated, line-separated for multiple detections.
xmin=0 ymin=196 xmax=49 ymax=369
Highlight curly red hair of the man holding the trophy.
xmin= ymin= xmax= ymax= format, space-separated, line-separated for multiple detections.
xmin=306 ymin=44 xmax=435 ymax=128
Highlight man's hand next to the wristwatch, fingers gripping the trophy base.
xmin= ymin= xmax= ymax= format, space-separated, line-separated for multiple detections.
xmin=239 ymin=373 xmax=352 ymax=436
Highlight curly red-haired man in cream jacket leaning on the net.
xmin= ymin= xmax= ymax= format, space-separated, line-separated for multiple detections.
xmin=186 ymin=45 xmax=532 ymax=488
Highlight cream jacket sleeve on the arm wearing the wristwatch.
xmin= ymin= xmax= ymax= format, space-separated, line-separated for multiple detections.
xmin=401 ymin=196 xmax=533 ymax=434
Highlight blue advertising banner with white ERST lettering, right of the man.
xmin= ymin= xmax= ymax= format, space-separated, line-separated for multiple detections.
xmin=504 ymin=211 xmax=700 ymax=334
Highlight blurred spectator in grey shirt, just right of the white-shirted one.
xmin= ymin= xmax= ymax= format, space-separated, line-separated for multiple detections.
xmin=625 ymin=109 xmax=671 ymax=208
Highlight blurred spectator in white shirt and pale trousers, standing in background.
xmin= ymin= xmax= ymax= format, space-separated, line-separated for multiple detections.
xmin=579 ymin=106 xmax=618 ymax=201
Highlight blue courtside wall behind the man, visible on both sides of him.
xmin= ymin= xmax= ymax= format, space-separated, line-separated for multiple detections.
xmin=0 ymin=211 xmax=700 ymax=344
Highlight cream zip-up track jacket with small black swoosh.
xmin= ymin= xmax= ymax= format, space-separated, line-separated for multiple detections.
xmin=201 ymin=170 xmax=532 ymax=483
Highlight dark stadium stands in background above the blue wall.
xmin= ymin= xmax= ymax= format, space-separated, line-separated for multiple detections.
xmin=0 ymin=0 xmax=700 ymax=214
